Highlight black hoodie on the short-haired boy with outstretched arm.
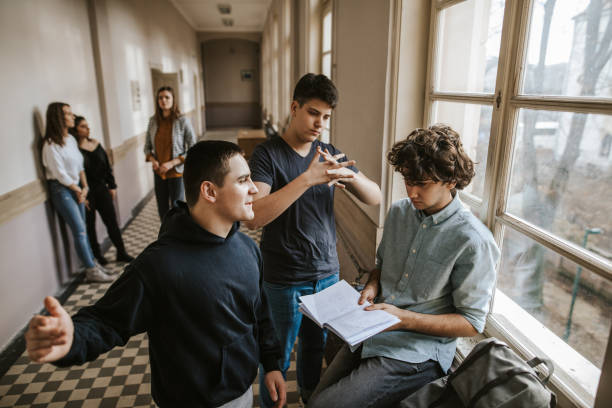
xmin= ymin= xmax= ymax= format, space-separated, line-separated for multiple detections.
xmin=56 ymin=203 xmax=280 ymax=407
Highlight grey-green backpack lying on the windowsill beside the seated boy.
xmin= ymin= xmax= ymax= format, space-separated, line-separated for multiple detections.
xmin=399 ymin=338 xmax=557 ymax=408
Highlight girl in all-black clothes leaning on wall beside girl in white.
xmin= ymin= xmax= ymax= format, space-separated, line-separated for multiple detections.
xmin=70 ymin=116 xmax=134 ymax=265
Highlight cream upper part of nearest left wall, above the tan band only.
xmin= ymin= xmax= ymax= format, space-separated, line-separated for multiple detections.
xmin=0 ymin=0 xmax=102 ymax=198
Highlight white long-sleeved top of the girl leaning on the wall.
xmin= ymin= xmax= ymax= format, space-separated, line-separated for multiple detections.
xmin=42 ymin=135 xmax=83 ymax=187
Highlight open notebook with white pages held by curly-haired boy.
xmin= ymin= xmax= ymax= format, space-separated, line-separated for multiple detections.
xmin=300 ymin=280 xmax=400 ymax=346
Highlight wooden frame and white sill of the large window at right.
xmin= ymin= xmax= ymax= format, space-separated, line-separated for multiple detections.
xmin=423 ymin=0 xmax=612 ymax=407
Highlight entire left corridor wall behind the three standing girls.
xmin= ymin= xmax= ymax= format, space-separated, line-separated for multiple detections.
xmin=0 ymin=0 xmax=202 ymax=349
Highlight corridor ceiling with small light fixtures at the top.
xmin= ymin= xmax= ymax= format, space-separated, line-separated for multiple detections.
xmin=170 ymin=0 xmax=271 ymax=32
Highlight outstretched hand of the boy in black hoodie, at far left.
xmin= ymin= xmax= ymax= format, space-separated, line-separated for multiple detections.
xmin=25 ymin=296 xmax=74 ymax=363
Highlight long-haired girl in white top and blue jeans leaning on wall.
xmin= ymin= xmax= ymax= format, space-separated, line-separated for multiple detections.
xmin=42 ymin=102 xmax=113 ymax=282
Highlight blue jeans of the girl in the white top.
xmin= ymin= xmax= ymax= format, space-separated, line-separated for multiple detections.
xmin=49 ymin=180 xmax=94 ymax=268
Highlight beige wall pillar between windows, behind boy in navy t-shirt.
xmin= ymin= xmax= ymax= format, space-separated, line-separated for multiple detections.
xmin=331 ymin=0 xmax=391 ymax=226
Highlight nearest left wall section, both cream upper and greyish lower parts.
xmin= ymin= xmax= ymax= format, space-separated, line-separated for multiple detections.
xmin=0 ymin=0 xmax=102 ymax=348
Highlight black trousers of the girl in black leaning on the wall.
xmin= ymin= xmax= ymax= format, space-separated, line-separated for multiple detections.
xmin=85 ymin=186 xmax=125 ymax=258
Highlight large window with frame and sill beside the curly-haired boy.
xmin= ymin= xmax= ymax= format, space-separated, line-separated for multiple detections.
xmin=425 ymin=0 xmax=612 ymax=406
